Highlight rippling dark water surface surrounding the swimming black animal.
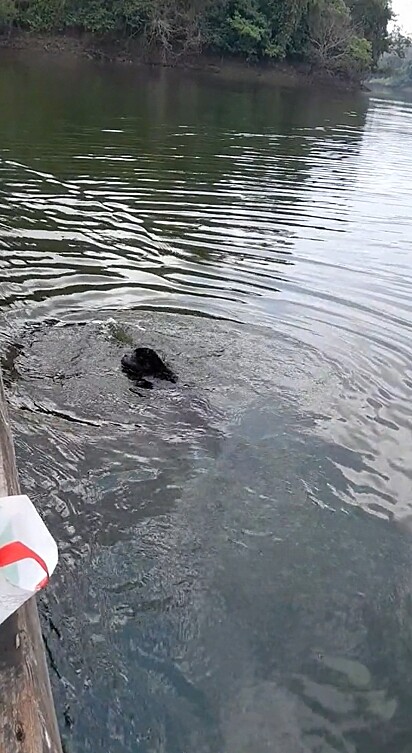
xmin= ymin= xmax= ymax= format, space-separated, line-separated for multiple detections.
xmin=0 ymin=58 xmax=412 ymax=753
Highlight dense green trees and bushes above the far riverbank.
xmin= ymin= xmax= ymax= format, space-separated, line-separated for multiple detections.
xmin=0 ymin=0 xmax=391 ymax=77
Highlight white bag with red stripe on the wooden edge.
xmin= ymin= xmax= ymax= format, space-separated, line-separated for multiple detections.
xmin=0 ymin=495 xmax=58 ymax=624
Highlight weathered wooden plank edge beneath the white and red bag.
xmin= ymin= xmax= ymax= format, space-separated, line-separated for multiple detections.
xmin=0 ymin=373 xmax=62 ymax=753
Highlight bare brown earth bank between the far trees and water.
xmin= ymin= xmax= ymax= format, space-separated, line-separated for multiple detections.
xmin=0 ymin=31 xmax=360 ymax=90
